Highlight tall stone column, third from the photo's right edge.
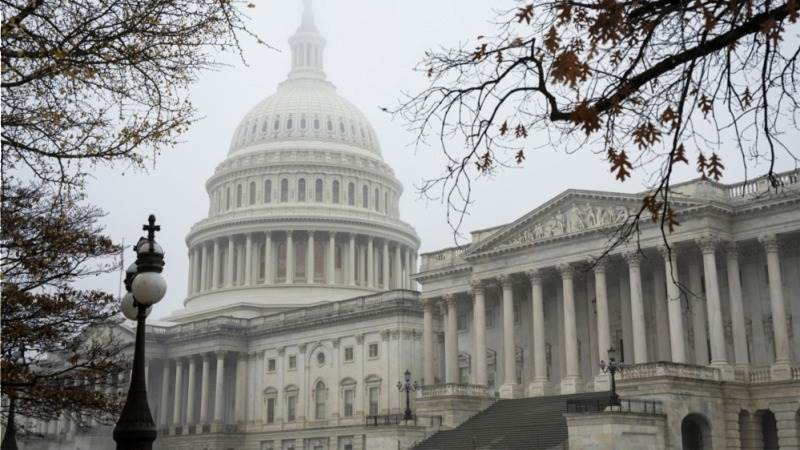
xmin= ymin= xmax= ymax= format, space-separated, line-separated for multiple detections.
xmin=695 ymin=235 xmax=728 ymax=366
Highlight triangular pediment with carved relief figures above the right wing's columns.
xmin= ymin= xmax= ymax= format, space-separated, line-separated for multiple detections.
xmin=465 ymin=190 xmax=696 ymax=257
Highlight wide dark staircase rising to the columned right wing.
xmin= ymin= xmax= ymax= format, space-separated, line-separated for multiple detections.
xmin=414 ymin=392 xmax=609 ymax=450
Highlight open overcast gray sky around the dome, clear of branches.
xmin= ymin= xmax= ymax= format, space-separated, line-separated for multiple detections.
xmin=81 ymin=0 xmax=788 ymax=318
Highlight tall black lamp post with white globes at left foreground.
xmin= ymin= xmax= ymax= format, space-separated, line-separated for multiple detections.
xmin=114 ymin=214 xmax=167 ymax=450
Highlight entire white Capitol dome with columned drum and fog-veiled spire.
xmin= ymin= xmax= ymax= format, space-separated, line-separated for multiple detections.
xmin=172 ymin=2 xmax=419 ymax=322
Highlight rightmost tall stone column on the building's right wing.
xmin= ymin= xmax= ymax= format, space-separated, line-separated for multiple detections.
xmin=760 ymin=234 xmax=791 ymax=372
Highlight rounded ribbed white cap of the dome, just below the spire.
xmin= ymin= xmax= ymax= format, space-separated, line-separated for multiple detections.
xmin=229 ymin=78 xmax=381 ymax=157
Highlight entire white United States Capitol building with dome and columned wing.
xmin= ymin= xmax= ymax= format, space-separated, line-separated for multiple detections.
xmin=26 ymin=3 xmax=800 ymax=450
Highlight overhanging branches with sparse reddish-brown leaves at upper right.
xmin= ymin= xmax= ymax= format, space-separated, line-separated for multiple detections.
xmin=391 ymin=0 xmax=800 ymax=246
